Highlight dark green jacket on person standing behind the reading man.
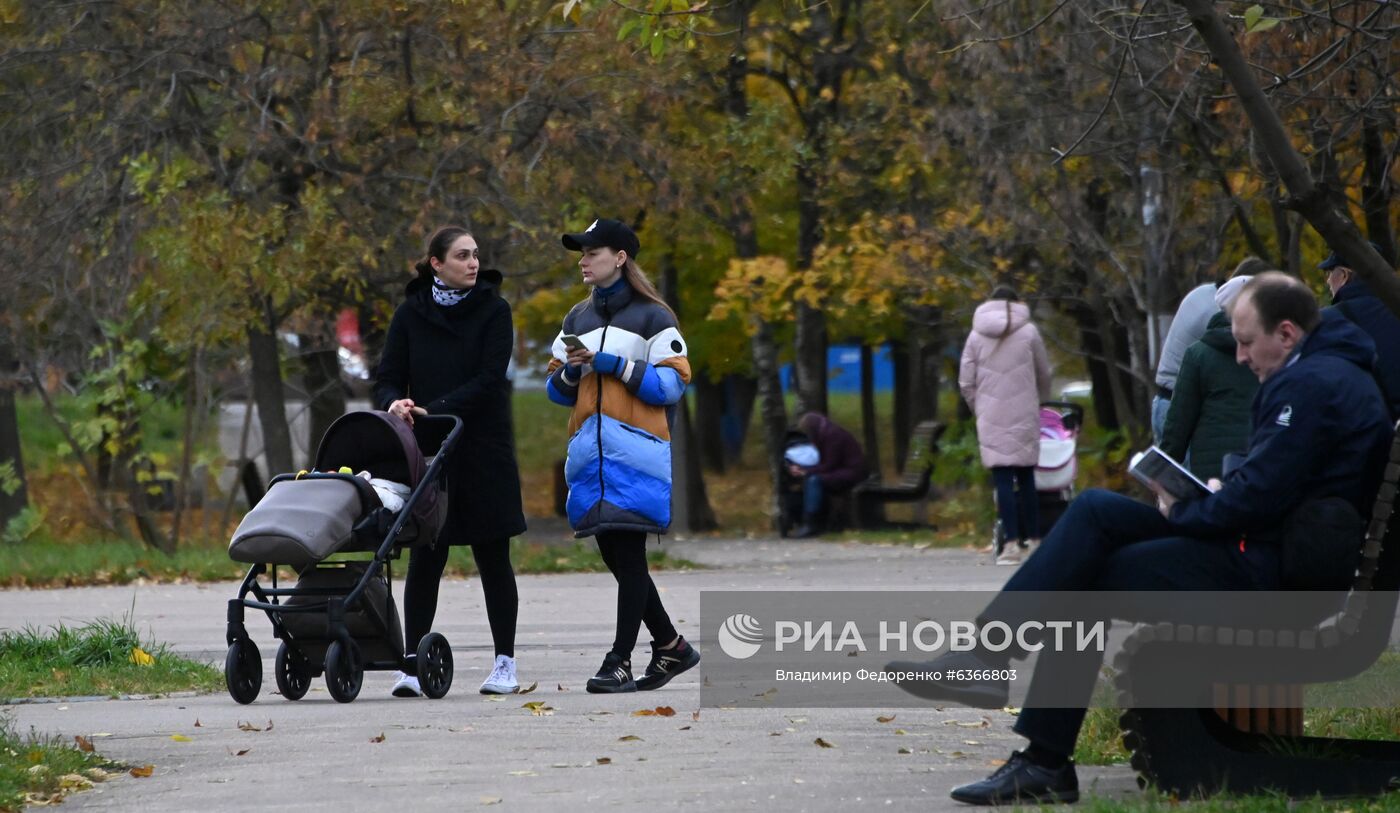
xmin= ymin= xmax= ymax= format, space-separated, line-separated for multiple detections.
xmin=1162 ymin=312 xmax=1259 ymax=480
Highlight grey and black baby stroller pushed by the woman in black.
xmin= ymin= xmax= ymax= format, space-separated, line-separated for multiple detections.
xmin=224 ymin=411 xmax=462 ymax=704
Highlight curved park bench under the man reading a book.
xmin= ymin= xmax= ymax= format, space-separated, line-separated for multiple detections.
xmin=1114 ymin=424 xmax=1400 ymax=799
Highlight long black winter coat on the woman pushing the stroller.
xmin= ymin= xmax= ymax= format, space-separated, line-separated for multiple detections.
xmin=374 ymin=270 xmax=525 ymax=544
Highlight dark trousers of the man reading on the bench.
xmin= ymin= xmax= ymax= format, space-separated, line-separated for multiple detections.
xmin=979 ymin=488 xmax=1278 ymax=756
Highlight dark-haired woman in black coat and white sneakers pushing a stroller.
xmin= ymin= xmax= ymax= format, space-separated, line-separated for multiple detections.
xmin=374 ymin=227 xmax=525 ymax=697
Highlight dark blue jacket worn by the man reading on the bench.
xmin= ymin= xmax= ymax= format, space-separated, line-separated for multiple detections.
xmin=1170 ymin=309 xmax=1392 ymax=542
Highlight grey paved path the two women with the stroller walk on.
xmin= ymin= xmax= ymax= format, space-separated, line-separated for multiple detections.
xmin=0 ymin=540 xmax=1137 ymax=812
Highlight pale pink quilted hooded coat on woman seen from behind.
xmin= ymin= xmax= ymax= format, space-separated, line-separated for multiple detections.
xmin=958 ymin=299 xmax=1050 ymax=469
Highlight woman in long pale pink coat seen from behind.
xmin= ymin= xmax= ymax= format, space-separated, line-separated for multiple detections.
xmin=958 ymin=285 xmax=1050 ymax=564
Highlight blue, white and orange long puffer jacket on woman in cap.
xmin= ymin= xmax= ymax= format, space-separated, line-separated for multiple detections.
xmin=546 ymin=280 xmax=690 ymax=537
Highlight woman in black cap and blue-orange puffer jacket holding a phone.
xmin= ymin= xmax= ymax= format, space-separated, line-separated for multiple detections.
xmin=547 ymin=220 xmax=700 ymax=694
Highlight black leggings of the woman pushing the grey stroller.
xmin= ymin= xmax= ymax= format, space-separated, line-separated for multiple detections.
xmin=403 ymin=539 xmax=519 ymax=658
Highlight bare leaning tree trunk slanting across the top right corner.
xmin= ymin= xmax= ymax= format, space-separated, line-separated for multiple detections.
xmin=1175 ymin=0 xmax=1400 ymax=315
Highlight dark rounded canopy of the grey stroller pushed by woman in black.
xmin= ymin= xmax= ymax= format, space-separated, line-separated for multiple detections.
xmin=315 ymin=410 xmax=438 ymax=521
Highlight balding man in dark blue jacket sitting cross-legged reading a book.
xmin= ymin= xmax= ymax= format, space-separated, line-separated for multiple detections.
xmin=888 ymin=271 xmax=1392 ymax=805
